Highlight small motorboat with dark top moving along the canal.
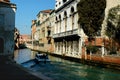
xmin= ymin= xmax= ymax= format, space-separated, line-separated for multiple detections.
xmin=35 ymin=53 xmax=50 ymax=63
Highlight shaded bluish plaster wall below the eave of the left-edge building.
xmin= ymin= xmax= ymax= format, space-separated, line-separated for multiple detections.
xmin=0 ymin=5 xmax=15 ymax=55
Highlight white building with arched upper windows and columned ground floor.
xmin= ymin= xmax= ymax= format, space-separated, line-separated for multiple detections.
xmin=53 ymin=0 xmax=85 ymax=58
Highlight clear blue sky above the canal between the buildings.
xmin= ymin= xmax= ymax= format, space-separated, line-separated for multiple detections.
xmin=10 ymin=0 xmax=55 ymax=35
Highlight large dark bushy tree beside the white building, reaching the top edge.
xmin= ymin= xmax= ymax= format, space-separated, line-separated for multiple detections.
xmin=77 ymin=0 xmax=106 ymax=40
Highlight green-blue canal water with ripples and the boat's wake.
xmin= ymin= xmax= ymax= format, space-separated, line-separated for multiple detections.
xmin=14 ymin=49 xmax=120 ymax=80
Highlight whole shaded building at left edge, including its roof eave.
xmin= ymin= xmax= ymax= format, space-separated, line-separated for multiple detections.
xmin=0 ymin=0 xmax=16 ymax=55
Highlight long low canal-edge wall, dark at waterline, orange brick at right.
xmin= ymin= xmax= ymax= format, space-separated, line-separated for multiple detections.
xmin=30 ymin=48 xmax=120 ymax=70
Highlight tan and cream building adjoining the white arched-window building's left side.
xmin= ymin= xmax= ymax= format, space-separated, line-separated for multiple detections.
xmin=32 ymin=9 xmax=53 ymax=51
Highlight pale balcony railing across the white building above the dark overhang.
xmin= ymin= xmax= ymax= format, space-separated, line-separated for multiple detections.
xmin=53 ymin=29 xmax=78 ymax=38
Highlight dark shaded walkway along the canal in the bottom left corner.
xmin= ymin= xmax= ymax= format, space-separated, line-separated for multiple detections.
xmin=0 ymin=56 xmax=49 ymax=80
